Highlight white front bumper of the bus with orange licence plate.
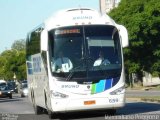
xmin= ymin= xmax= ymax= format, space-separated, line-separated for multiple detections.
xmin=51 ymin=95 xmax=125 ymax=112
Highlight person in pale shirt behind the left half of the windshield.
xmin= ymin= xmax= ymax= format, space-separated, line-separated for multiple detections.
xmin=52 ymin=51 xmax=73 ymax=73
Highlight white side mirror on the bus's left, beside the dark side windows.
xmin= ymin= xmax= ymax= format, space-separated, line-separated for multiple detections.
xmin=41 ymin=29 xmax=48 ymax=51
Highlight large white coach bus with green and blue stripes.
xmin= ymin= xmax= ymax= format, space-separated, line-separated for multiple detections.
xmin=26 ymin=8 xmax=128 ymax=118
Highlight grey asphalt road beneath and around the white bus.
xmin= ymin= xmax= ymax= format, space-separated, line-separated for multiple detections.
xmin=0 ymin=91 xmax=160 ymax=120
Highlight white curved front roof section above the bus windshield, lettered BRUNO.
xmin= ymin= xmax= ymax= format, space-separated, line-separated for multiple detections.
xmin=44 ymin=8 xmax=115 ymax=30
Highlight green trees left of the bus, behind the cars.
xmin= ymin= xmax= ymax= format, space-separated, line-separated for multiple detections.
xmin=0 ymin=40 xmax=26 ymax=80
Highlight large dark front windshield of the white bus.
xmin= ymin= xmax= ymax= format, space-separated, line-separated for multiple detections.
xmin=49 ymin=25 xmax=122 ymax=81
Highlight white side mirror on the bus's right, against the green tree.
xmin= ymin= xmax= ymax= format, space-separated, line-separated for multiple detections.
xmin=118 ymin=25 xmax=129 ymax=48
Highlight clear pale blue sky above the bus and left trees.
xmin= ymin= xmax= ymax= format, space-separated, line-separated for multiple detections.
xmin=0 ymin=0 xmax=99 ymax=53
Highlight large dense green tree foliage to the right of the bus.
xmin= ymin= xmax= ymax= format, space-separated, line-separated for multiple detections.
xmin=109 ymin=0 xmax=160 ymax=76
